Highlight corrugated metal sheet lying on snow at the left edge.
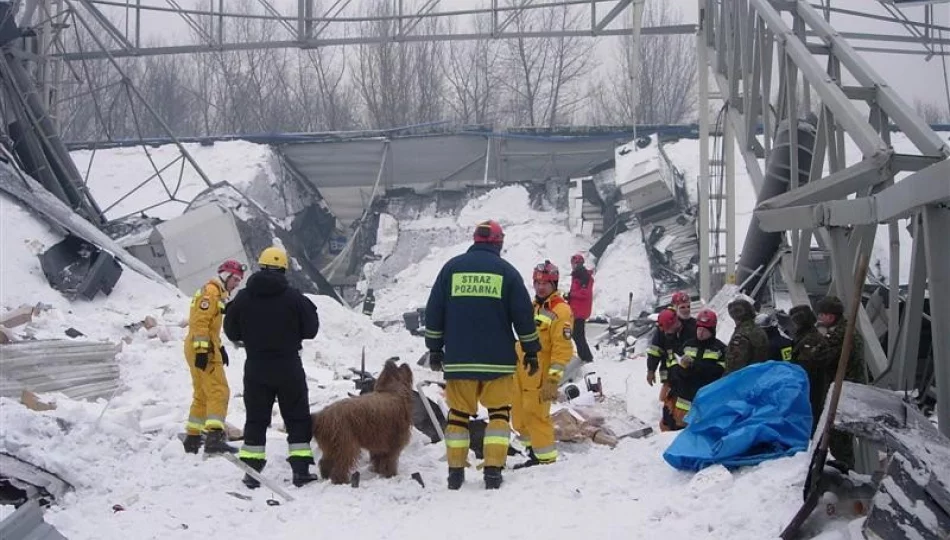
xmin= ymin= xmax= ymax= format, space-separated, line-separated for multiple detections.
xmin=0 ymin=340 xmax=119 ymax=399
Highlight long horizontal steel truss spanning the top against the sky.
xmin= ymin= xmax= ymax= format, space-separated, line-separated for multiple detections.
xmin=41 ymin=0 xmax=696 ymax=59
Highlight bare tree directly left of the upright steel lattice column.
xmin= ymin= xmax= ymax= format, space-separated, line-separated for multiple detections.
xmin=591 ymin=1 xmax=696 ymax=124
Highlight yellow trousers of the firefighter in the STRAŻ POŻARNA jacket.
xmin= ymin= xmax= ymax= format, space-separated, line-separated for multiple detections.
xmin=445 ymin=375 xmax=515 ymax=468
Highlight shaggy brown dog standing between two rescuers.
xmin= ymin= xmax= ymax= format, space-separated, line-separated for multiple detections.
xmin=311 ymin=360 xmax=413 ymax=484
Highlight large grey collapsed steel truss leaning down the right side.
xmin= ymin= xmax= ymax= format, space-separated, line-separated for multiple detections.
xmin=698 ymin=0 xmax=950 ymax=435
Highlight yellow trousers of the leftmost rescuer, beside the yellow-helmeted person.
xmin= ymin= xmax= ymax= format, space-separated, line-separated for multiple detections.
xmin=185 ymin=354 xmax=231 ymax=435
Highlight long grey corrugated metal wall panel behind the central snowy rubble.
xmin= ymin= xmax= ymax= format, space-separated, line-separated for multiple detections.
xmin=277 ymin=133 xmax=617 ymax=225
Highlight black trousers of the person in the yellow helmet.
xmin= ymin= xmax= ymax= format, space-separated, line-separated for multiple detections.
xmin=244 ymin=366 xmax=313 ymax=458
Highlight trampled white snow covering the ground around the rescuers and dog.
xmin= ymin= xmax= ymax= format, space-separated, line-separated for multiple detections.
xmin=0 ymin=145 xmax=876 ymax=540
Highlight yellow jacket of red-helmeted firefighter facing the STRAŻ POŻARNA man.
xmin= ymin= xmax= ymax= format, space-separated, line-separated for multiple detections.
xmin=516 ymin=291 xmax=574 ymax=388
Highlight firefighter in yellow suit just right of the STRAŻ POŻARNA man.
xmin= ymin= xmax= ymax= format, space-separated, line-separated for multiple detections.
xmin=511 ymin=261 xmax=576 ymax=469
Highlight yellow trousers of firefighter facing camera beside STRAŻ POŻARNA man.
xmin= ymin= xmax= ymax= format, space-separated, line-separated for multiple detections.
xmin=511 ymin=362 xmax=557 ymax=463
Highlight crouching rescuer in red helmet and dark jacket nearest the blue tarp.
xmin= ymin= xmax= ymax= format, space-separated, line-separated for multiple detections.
xmin=663 ymin=309 xmax=726 ymax=431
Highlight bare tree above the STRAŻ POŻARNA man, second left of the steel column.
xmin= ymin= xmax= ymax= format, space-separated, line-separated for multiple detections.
xmin=502 ymin=0 xmax=594 ymax=127
